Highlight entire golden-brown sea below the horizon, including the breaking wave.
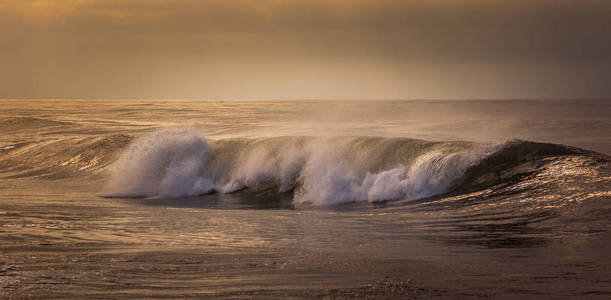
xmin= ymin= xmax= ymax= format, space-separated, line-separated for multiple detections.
xmin=0 ymin=100 xmax=611 ymax=299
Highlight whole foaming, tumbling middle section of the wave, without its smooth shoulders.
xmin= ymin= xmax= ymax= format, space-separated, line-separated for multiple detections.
xmin=106 ymin=128 xmax=492 ymax=205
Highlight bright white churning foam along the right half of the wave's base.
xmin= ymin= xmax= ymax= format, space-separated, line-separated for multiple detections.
xmin=295 ymin=151 xmax=483 ymax=205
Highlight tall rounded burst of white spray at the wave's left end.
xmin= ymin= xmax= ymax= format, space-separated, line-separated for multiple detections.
xmin=107 ymin=128 xmax=213 ymax=197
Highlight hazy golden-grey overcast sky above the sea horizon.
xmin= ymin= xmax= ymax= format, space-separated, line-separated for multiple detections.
xmin=0 ymin=0 xmax=611 ymax=99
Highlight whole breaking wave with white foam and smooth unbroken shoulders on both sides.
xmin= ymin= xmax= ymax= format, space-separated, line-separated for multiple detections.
xmin=0 ymin=128 xmax=609 ymax=205
